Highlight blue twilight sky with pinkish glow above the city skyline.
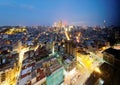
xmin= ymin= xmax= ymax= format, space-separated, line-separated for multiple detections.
xmin=0 ymin=0 xmax=120 ymax=25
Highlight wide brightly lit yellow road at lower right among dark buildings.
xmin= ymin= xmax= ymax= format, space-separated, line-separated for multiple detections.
xmin=63 ymin=50 xmax=104 ymax=85
